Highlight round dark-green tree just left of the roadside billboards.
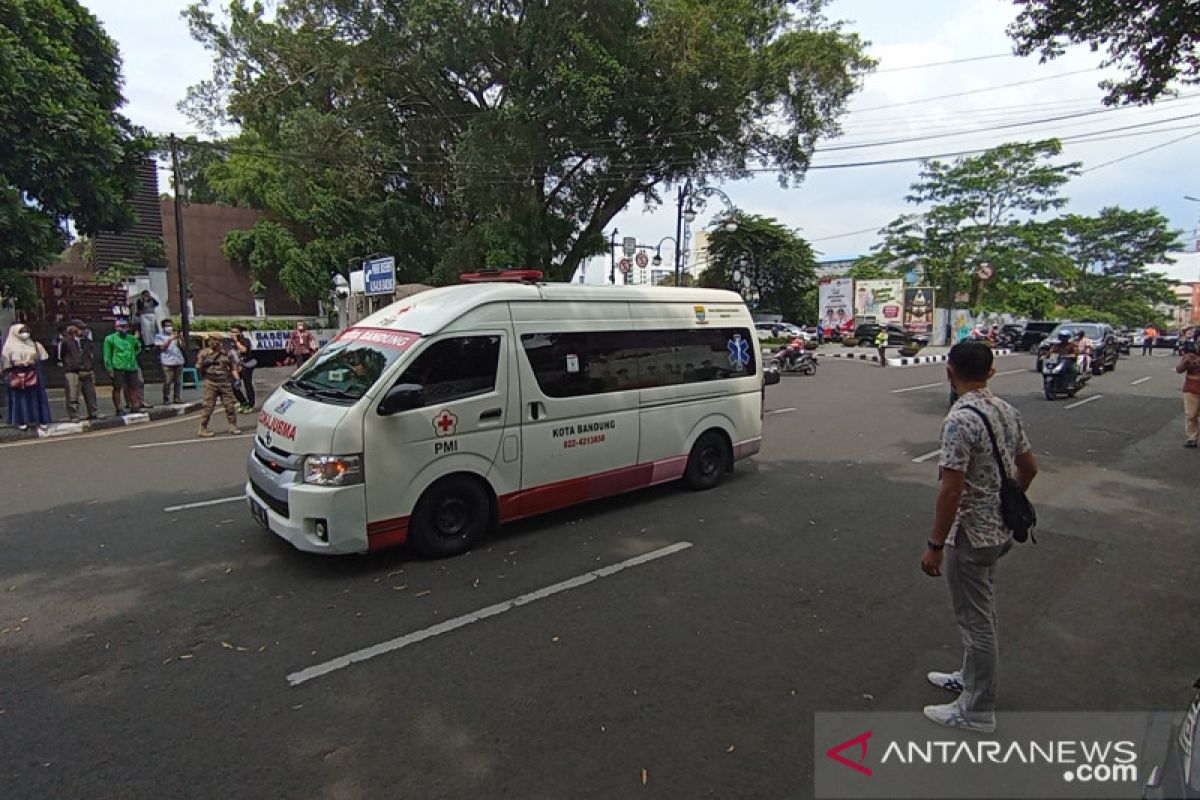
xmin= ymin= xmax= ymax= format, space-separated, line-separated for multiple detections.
xmin=700 ymin=213 xmax=817 ymax=317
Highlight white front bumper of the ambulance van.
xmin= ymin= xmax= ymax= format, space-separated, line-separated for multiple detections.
xmin=246 ymin=452 xmax=368 ymax=555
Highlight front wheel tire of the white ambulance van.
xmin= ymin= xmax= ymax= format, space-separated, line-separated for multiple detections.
xmin=408 ymin=475 xmax=492 ymax=558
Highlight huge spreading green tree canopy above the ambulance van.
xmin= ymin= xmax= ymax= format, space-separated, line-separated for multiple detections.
xmin=187 ymin=0 xmax=871 ymax=293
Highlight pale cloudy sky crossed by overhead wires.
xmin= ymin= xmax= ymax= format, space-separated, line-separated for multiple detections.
xmin=83 ymin=0 xmax=1200 ymax=286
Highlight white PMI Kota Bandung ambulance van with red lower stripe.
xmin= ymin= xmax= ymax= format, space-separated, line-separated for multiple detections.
xmin=246 ymin=277 xmax=778 ymax=557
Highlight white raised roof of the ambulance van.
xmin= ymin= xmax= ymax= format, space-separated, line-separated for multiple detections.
xmin=355 ymin=283 xmax=743 ymax=335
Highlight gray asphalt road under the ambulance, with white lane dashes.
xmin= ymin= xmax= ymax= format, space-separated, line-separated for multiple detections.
xmin=0 ymin=356 xmax=1200 ymax=799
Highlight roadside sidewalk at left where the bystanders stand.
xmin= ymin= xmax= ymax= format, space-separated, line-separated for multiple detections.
xmin=0 ymin=367 xmax=292 ymax=443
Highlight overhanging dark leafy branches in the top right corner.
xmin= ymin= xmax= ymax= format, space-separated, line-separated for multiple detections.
xmin=1008 ymin=0 xmax=1200 ymax=106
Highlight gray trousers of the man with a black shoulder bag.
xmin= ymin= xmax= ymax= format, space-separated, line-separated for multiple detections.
xmin=946 ymin=530 xmax=1010 ymax=712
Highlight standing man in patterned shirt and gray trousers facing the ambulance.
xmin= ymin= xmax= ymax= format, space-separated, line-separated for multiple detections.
xmin=920 ymin=342 xmax=1038 ymax=733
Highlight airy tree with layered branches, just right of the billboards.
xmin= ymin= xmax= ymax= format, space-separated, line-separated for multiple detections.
xmin=868 ymin=139 xmax=1079 ymax=307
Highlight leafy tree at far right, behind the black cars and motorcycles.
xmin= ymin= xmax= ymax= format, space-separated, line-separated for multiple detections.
xmin=1057 ymin=207 xmax=1182 ymax=325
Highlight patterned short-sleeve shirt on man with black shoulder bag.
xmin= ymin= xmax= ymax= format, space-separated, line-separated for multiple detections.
xmin=938 ymin=389 xmax=1030 ymax=547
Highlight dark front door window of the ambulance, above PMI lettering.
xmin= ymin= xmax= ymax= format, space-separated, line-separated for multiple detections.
xmin=396 ymin=336 xmax=500 ymax=405
